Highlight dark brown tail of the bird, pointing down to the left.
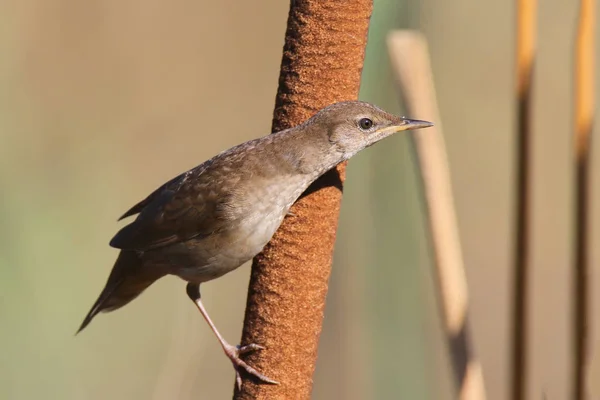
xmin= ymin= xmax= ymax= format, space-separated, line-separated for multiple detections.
xmin=77 ymin=250 xmax=166 ymax=333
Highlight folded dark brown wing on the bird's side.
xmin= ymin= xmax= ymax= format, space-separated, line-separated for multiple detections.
xmin=110 ymin=173 xmax=228 ymax=250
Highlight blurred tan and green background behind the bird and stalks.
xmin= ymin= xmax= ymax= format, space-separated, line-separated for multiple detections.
xmin=0 ymin=0 xmax=600 ymax=400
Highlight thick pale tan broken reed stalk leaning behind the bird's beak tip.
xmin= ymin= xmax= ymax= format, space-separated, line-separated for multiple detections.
xmin=388 ymin=31 xmax=486 ymax=400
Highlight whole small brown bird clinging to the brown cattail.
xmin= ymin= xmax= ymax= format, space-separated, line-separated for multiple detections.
xmin=78 ymin=101 xmax=432 ymax=386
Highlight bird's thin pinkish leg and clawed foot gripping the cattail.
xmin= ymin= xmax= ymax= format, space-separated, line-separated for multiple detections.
xmin=186 ymin=283 xmax=279 ymax=389
